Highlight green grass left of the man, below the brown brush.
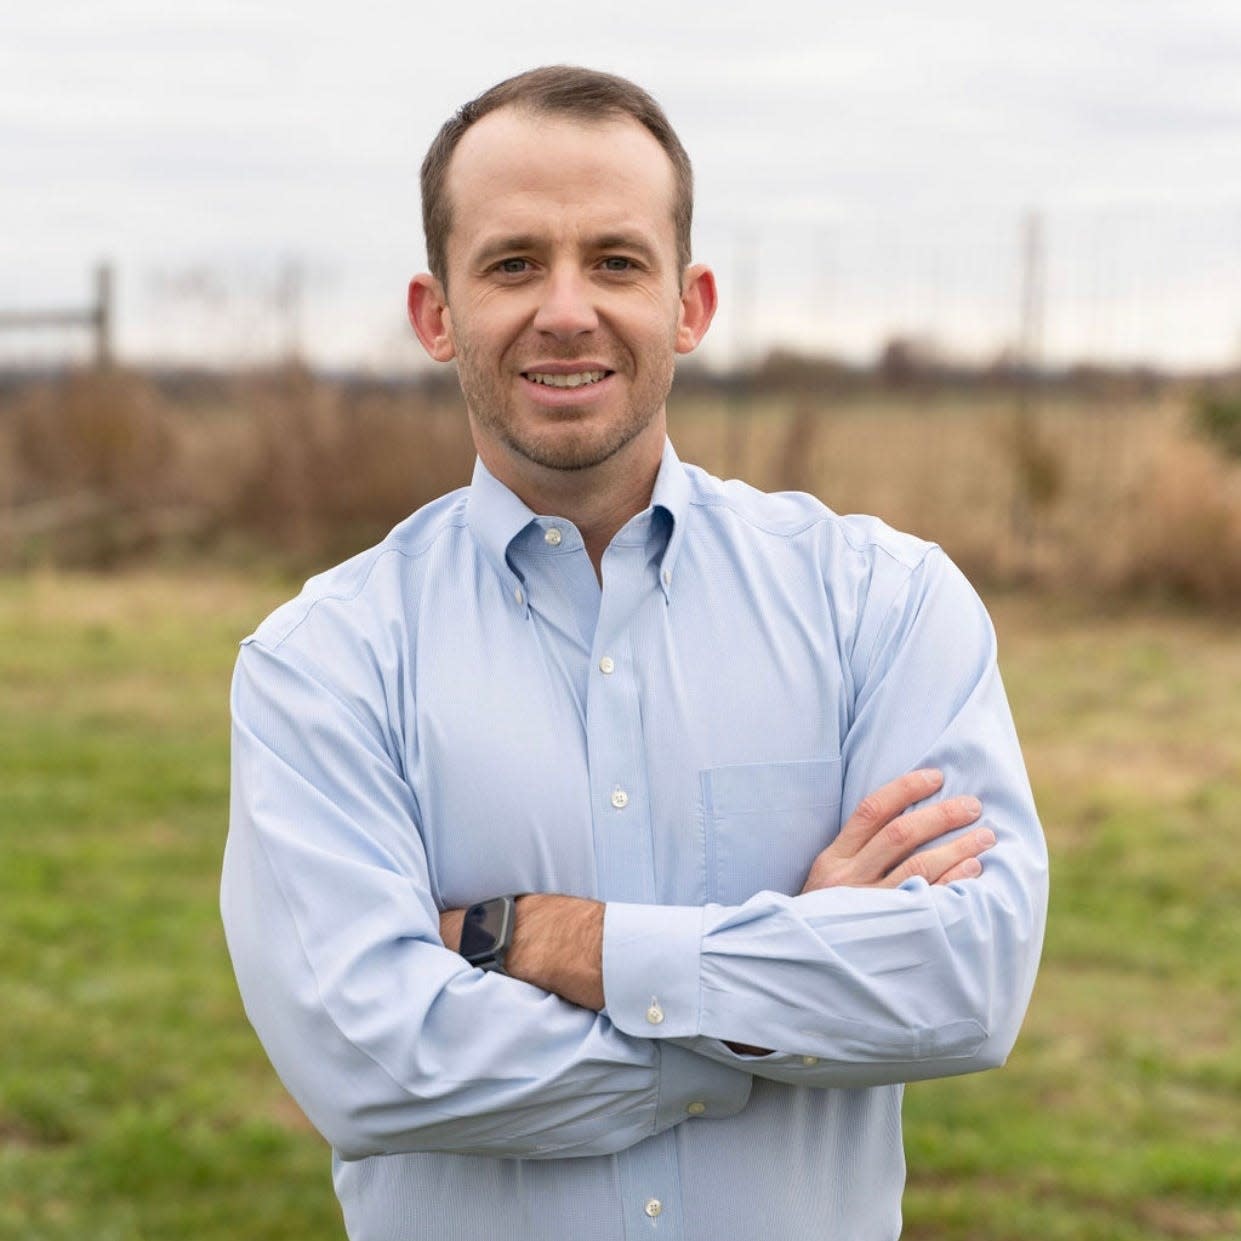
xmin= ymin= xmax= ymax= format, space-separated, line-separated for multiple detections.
xmin=0 ymin=576 xmax=343 ymax=1241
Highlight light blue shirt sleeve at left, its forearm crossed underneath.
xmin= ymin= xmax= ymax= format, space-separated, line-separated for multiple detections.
xmin=221 ymin=639 xmax=752 ymax=1159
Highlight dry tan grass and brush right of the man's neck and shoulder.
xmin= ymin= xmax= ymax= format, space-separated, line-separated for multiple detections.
xmin=673 ymin=384 xmax=1241 ymax=606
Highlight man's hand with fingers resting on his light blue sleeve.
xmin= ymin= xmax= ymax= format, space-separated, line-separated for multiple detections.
xmin=802 ymin=771 xmax=995 ymax=892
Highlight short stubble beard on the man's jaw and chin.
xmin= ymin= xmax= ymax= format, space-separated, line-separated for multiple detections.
xmin=457 ymin=339 xmax=675 ymax=470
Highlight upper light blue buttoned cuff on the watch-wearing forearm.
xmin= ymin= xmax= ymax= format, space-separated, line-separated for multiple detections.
xmin=603 ymin=901 xmax=705 ymax=1039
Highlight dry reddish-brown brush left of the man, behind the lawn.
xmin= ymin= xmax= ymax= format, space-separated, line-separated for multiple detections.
xmin=0 ymin=370 xmax=473 ymax=566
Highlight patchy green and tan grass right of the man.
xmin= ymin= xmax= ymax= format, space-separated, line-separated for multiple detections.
xmin=906 ymin=599 xmax=1241 ymax=1241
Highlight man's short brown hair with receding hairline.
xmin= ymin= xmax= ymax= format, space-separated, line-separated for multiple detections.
xmin=422 ymin=65 xmax=694 ymax=283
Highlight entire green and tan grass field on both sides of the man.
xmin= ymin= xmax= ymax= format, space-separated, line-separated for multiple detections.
xmin=0 ymin=571 xmax=1241 ymax=1241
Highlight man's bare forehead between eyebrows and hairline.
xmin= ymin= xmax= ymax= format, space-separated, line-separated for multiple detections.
xmin=447 ymin=108 xmax=675 ymax=263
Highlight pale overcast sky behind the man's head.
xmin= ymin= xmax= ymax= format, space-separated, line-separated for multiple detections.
xmin=0 ymin=0 xmax=1241 ymax=365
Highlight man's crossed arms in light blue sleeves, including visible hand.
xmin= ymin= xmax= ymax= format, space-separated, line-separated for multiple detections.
xmin=222 ymin=548 xmax=1046 ymax=1159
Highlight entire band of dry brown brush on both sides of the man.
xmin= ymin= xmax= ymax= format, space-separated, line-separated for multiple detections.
xmin=0 ymin=370 xmax=1241 ymax=607
